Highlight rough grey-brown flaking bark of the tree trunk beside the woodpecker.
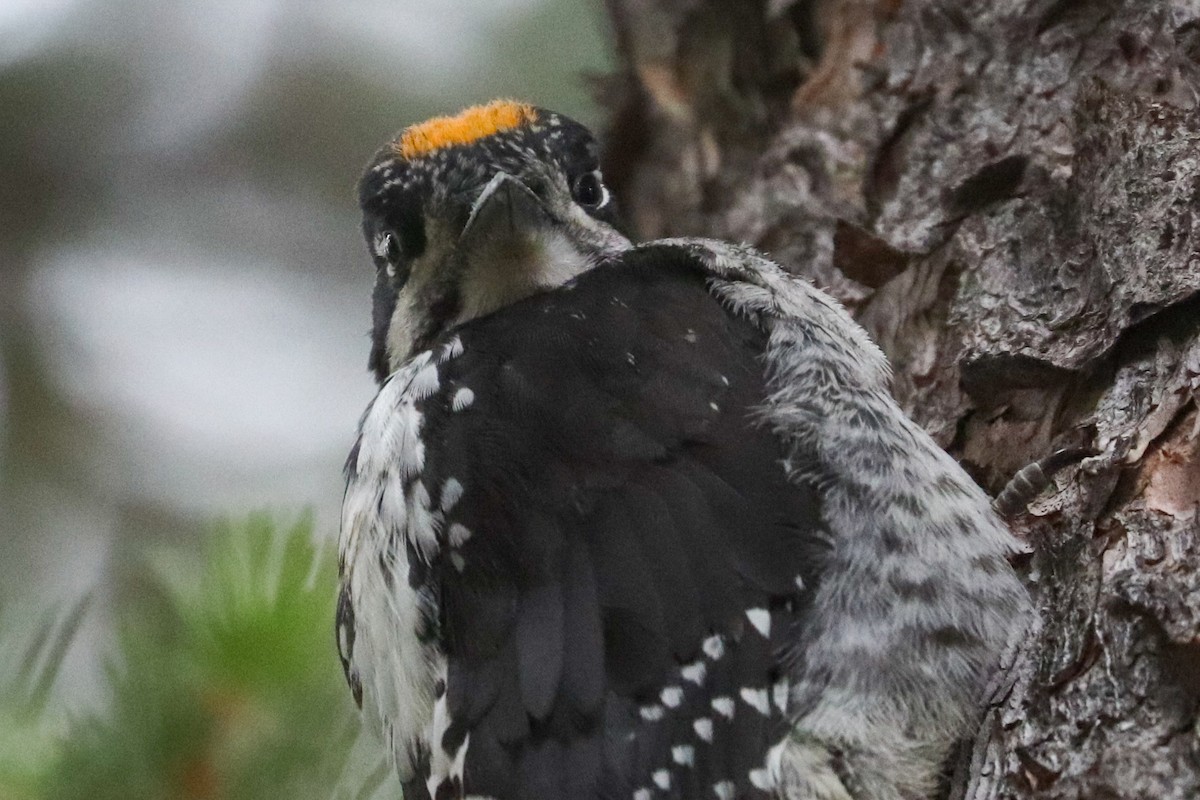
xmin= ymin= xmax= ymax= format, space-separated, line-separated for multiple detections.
xmin=606 ymin=0 xmax=1200 ymax=800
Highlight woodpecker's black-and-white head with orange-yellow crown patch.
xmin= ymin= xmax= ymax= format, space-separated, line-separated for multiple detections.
xmin=359 ymin=101 xmax=630 ymax=381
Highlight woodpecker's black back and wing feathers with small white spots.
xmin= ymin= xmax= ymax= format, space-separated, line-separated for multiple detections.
xmin=343 ymin=249 xmax=826 ymax=800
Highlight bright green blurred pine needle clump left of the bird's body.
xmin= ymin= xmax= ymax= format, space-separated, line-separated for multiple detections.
xmin=36 ymin=515 xmax=388 ymax=800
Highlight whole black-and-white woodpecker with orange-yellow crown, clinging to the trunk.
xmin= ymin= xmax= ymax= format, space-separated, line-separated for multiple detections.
xmin=336 ymin=101 xmax=1028 ymax=800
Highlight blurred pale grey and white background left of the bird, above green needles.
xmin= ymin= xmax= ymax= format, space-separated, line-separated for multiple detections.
xmin=0 ymin=0 xmax=611 ymax=796
